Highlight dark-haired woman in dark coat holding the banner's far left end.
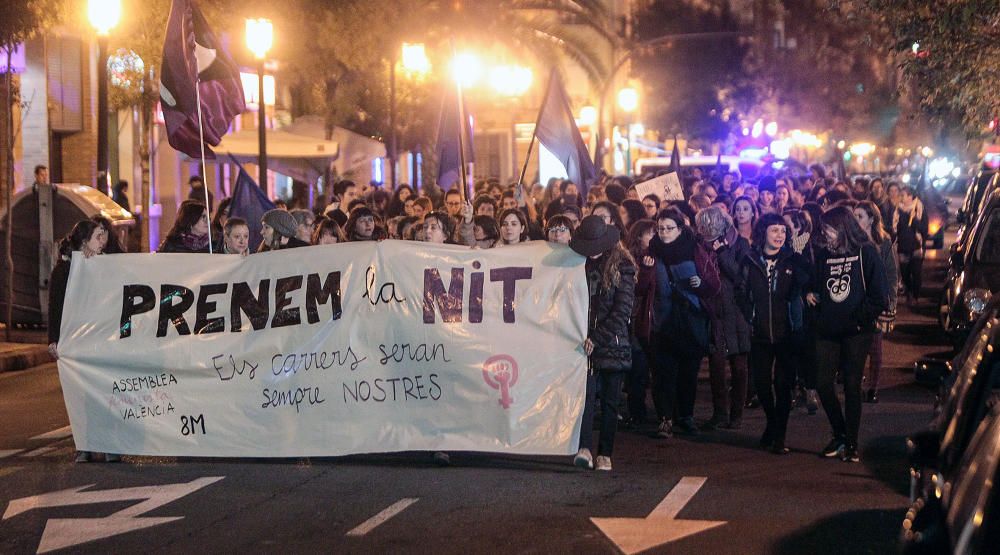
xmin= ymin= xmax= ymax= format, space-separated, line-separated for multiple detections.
xmin=49 ymin=222 xmax=121 ymax=463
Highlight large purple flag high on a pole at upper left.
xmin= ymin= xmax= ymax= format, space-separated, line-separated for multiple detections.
xmin=160 ymin=0 xmax=246 ymax=158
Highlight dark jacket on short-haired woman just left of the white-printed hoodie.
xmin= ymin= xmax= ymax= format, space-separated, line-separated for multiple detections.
xmin=741 ymin=247 xmax=809 ymax=344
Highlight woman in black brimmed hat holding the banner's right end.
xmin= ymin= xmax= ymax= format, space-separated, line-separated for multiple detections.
xmin=569 ymin=216 xmax=636 ymax=471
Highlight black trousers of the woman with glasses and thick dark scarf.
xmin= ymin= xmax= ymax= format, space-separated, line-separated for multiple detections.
xmin=653 ymin=346 xmax=702 ymax=420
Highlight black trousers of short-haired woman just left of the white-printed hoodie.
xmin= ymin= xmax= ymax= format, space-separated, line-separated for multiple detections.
xmin=750 ymin=341 xmax=795 ymax=443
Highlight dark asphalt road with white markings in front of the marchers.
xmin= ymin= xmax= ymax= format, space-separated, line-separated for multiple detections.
xmin=0 ymin=251 xmax=948 ymax=554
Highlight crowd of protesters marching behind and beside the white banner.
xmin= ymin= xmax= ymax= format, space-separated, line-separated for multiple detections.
xmin=49 ymin=165 xmax=927 ymax=470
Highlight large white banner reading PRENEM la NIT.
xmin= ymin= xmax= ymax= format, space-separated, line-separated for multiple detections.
xmin=59 ymin=241 xmax=588 ymax=457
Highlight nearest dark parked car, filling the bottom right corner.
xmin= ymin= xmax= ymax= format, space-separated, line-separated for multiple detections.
xmin=902 ymin=300 xmax=1000 ymax=554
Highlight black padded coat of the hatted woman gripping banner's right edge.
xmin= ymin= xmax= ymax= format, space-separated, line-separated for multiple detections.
xmin=587 ymin=251 xmax=636 ymax=372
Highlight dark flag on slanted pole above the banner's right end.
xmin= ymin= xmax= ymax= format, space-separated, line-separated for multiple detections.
xmin=535 ymin=69 xmax=597 ymax=197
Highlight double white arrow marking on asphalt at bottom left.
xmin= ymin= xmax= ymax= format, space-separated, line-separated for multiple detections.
xmin=3 ymin=476 xmax=225 ymax=553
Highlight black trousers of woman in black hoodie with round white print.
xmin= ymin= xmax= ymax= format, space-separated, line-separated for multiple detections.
xmin=816 ymin=333 xmax=873 ymax=447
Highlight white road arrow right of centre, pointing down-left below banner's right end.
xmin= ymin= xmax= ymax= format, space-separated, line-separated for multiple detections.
xmin=590 ymin=476 xmax=726 ymax=555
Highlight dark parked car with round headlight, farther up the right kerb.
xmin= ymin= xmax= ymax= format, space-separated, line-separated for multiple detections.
xmin=938 ymin=191 xmax=1000 ymax=342
